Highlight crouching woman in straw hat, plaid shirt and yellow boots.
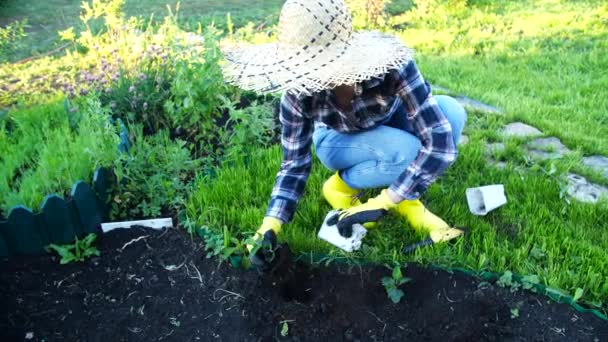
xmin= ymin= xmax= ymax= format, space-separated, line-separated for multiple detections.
xmin=224 ymin=0 xmax=466 ymax=268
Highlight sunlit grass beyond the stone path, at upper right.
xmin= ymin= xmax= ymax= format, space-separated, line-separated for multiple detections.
xmin=394 ymin=0 xmax=608 ymax=155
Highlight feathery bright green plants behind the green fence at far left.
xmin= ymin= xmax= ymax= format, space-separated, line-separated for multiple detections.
xmin=0 ymin=97 xmax=119 ymax=213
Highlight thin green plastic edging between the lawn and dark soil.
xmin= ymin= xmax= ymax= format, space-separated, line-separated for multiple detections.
xmin=294 ymin=253 xmax=608 ymax=321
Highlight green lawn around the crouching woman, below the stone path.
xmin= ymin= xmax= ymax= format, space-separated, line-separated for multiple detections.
xmin=188 ymin=113 xmax=608 ymax=303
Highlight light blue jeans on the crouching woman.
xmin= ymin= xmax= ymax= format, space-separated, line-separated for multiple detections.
xmin=313 ymin=95 xmax=467 ymax=189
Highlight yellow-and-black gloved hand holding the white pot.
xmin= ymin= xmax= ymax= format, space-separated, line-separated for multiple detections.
xmin=337 ymin=189 xmax=397 ymax=238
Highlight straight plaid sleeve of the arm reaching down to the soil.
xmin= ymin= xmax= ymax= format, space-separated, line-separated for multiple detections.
xmin=266 ymin=92 xmax=314 ymax=223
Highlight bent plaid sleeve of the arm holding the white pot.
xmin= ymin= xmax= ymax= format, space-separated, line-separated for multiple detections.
xmin=390 ymin=61 xmax=458 ymax=200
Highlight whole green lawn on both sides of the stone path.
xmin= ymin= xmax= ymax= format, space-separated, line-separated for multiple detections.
xmin=189 ymin=1 xmax=608 ymax=305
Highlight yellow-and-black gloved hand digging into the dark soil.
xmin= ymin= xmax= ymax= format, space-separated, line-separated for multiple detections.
xmin=247 ymin=216 xmax=283 ymax=271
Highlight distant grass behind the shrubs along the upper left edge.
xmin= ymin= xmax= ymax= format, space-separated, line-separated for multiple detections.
xmin=0 ymin=0 xmax=284 ymax=61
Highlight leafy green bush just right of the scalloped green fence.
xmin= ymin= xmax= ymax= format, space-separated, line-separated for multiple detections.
xmin=111 ymin=127 xmax=200 ymax=219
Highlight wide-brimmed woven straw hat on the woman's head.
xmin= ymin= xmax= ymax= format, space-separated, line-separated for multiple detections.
xmin=222 ymin=0 xmax=413 ymax=94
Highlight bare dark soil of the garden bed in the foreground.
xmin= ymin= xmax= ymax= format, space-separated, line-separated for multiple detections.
xmin=0 ymin=228 xmax=608 ymax=341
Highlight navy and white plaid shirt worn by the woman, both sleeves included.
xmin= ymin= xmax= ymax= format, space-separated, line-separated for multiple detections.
xmin=266 ymin=61 xmax=457 ymax=222
